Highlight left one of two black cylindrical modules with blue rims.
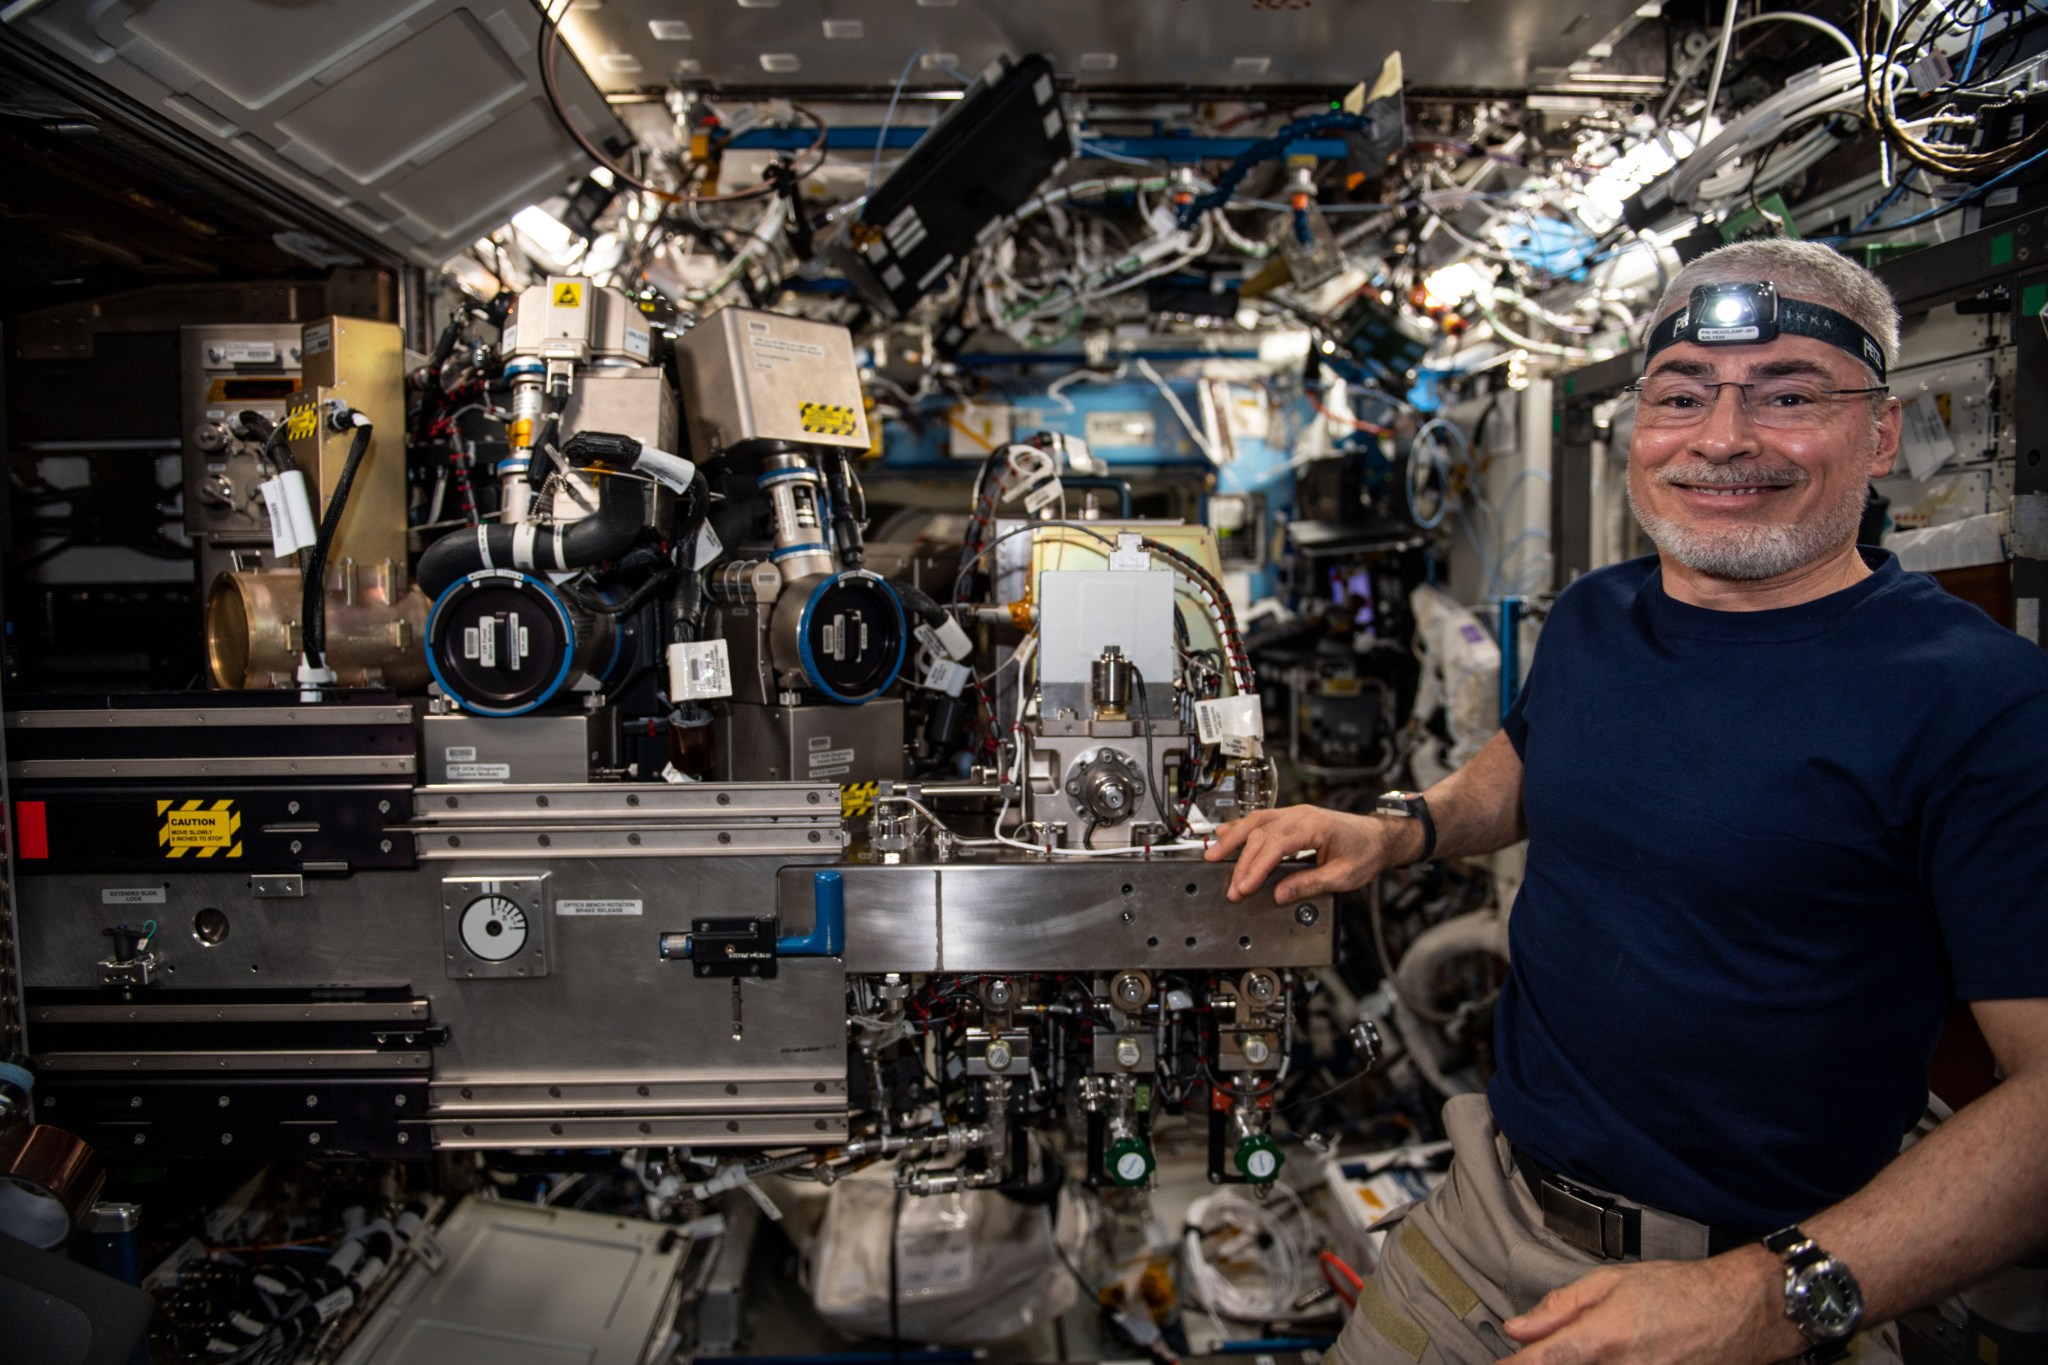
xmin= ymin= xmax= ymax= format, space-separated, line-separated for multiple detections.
xmin=426 ymin=569 xmax=618 ymax=716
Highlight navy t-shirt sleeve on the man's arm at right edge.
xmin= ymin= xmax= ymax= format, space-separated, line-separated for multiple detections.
xmin=1921 ymin=675 xmax=2048 ymax=1001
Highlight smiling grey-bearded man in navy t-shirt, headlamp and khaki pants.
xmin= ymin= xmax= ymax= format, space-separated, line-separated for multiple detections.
xmin=1210 ymin=241 xmax=2048 ymax=1365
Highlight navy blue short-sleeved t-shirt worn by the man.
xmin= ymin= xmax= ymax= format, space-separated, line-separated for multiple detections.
xmin=1489 ymin=553 xmax=2048 ymax=1234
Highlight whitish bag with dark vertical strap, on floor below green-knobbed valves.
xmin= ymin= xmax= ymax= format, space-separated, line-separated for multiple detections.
xmin=807 ymin=1166 xmax=1085 ymax=1347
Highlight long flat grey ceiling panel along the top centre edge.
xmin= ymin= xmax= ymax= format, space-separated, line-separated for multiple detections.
xmin=565 ymin=0 xmax=1638 ymax=92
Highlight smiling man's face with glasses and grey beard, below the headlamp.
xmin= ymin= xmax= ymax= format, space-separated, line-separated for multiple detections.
xmin=1628 ymin=336 xmax=1901 ymax=581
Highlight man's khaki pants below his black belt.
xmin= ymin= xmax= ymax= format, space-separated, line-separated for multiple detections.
xmin=1331 ymin=1095 xmax=1898 ymax=1365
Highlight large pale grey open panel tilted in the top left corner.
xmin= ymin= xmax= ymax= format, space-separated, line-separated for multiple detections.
xmin=12 ymin=0 xmax=621 ymax=264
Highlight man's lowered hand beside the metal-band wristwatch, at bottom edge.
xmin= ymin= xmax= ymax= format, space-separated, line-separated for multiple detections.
xmin=1505 ymin=1246 xmax=1806 ymax=1365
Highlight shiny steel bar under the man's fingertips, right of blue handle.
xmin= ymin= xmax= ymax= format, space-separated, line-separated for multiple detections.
xmin=778 ymin=857 xmax=1335 ymax=972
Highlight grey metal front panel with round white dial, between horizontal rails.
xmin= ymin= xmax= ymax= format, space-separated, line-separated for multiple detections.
xmin=18 ymin=859 xmax=846 ymax=1087
